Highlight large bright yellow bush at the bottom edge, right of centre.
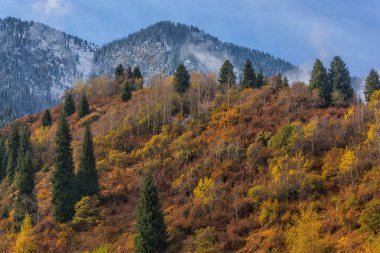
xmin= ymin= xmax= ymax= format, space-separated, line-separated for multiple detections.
xmin=286 ymin=210 xmax=323 ymax=253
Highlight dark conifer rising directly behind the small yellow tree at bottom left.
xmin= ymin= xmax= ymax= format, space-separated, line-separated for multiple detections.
xmin=13 ymin=151 xmax=38 ymax=231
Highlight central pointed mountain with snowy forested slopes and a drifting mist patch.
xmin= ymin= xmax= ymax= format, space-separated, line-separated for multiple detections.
xmin=94 ymin=21 xmax=295 ymax=79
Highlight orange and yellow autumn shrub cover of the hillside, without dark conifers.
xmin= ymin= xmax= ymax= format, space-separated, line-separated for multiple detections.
xmin=0 ymin=69 xmax=380 ymax=253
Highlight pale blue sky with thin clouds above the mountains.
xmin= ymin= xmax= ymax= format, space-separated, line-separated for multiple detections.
xmin=0 ymin=0 xmax=380 ymax=76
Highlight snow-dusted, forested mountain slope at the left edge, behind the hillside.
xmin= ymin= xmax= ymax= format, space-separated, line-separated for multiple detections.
xmin=0 ymin=18 xmax=97 ymax=119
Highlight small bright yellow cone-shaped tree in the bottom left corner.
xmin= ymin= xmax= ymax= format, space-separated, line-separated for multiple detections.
xmin=14 ymin=214 xmax=36 ymax=253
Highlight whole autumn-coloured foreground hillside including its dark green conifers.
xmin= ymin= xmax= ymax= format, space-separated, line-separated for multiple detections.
xmin=0 ymin=52 xmax=380 ymax=253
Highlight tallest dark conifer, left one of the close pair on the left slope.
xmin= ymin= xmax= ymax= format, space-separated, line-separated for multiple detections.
xmin=52 ymin=114 xmax=76 ymax=222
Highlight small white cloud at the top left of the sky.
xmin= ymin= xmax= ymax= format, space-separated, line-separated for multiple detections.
xmin=33 ymin=0 xmax=71 ymax=16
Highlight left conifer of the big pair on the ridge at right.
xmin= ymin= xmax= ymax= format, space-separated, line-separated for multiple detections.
xmin=309 ymin=59 xmax=333 ymax=105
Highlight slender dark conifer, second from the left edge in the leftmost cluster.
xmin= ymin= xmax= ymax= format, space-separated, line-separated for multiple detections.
xmin=6 ymin=124 xmax=20 ymax=181
